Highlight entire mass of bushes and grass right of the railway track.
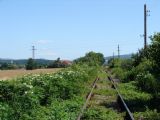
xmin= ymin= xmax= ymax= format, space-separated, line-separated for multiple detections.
xmin=109 ymin=33 xmax=160 ymax=120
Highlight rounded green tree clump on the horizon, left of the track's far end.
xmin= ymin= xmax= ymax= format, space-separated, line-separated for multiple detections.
xmin=74 ymin=52 xmax=105 ymax=66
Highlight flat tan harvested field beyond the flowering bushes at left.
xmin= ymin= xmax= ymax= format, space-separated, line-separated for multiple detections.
xmin=0 ymin=68 xmax=61 ymax=80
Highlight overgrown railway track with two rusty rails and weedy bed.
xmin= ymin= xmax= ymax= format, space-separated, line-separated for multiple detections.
xmin=77 ymin=72 xmax=134 ymax=120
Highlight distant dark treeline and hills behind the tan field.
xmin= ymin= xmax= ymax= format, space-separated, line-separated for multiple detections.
xmin=0 ymin=58 xmax=71 ymax=70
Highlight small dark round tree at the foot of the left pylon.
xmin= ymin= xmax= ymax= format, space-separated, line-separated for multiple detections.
xmin=26 ymin=58 xmax=37 ymax=70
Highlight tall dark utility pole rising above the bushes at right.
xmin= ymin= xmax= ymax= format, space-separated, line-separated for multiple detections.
xmin=144 ymin=4 xmax=150 ymax=49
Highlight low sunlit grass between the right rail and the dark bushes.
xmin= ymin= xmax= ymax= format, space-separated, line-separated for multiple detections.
xmin=118 ymin=81 xmax=160 ymax=120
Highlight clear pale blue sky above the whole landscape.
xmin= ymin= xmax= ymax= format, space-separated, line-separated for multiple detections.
xmin=0 ymin=0 xmax=160 ymax=60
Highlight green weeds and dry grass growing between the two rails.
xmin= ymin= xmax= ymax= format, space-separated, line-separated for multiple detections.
xmin=82 ymin=76 xmax=125 ymax=120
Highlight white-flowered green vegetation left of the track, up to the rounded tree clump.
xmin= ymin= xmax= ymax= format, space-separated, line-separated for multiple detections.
xmin=0 ymin=52 xmax=104 ymax=120
